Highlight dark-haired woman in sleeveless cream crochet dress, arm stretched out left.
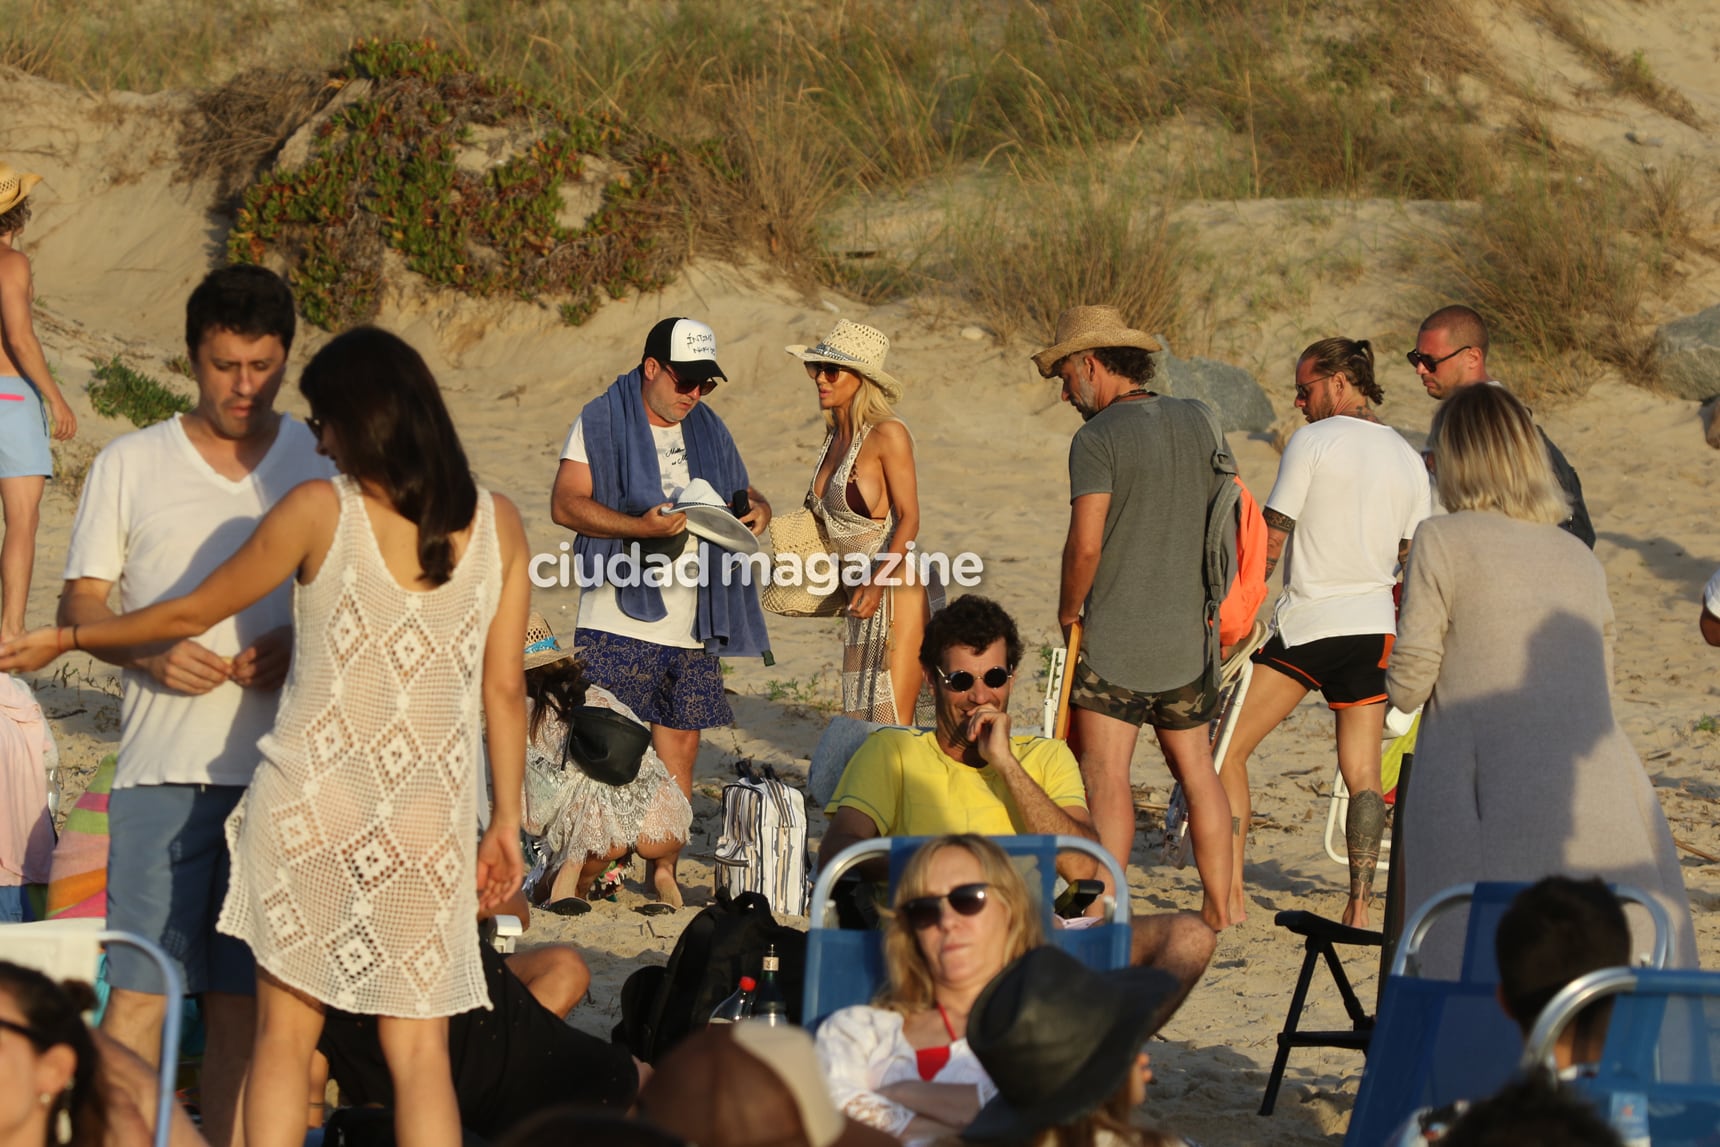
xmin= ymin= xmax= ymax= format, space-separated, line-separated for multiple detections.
xmin=0 ymin=327 xmax=530 ymax=1147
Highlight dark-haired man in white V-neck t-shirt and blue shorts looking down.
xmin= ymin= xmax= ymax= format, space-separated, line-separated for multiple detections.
xmin=58 ymin=267 xmax=334 ymax=1147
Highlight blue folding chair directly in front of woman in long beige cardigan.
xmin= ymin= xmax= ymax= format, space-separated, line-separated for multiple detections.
xmin=1343 ymin=884 xmax=1672 ymax=1147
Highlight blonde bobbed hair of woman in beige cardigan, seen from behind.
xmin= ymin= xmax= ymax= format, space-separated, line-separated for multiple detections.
xmin=1429 ymin=382 xmax=1570 ymax=526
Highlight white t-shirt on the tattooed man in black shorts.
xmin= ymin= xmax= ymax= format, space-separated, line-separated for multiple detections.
xmin=1266 ymin=414 xmax=1429 ymax=647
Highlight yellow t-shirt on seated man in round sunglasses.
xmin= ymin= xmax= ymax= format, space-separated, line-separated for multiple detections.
xmin=824 ymin=729 xmax=1087 ymax=836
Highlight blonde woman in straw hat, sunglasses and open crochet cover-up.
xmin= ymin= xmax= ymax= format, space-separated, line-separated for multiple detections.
xmin=788 ymin=318 xmax=943 ymax=724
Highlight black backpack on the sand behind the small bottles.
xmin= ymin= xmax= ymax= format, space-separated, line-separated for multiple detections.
xmin=612 ymin=891 xmax=807 ymax=1063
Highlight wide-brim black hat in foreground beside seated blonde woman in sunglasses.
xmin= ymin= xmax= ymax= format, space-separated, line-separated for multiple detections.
xmin=961 ymin=946 xmax=1180 ymax=1144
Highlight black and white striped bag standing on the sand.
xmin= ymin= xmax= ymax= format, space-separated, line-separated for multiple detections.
xmin=716 ymin=760 xmax=812 ymax=917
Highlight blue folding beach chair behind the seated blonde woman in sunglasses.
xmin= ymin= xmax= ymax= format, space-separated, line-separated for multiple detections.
xmin=800 ymin=836 xmax=1130 ymax=1030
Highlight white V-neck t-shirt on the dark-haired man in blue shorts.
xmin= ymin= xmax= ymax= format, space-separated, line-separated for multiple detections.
xmin=65 ymin=416 xmax=334 ymax=789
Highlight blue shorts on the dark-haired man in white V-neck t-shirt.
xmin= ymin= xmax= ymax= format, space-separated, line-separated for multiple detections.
xmin=108 ymin=784 xmax=256 ymax=996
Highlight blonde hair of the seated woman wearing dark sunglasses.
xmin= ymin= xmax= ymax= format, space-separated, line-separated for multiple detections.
xmin=874 ymin=832 xmax=1046 ymax=1015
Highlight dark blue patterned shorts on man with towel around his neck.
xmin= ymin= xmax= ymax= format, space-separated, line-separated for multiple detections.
xmin=574 ymin=629 xmax=734 ymax=729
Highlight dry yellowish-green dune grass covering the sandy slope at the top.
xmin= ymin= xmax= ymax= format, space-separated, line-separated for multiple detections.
xmin=0 ymin=0 xmax=1694 ymax=385
